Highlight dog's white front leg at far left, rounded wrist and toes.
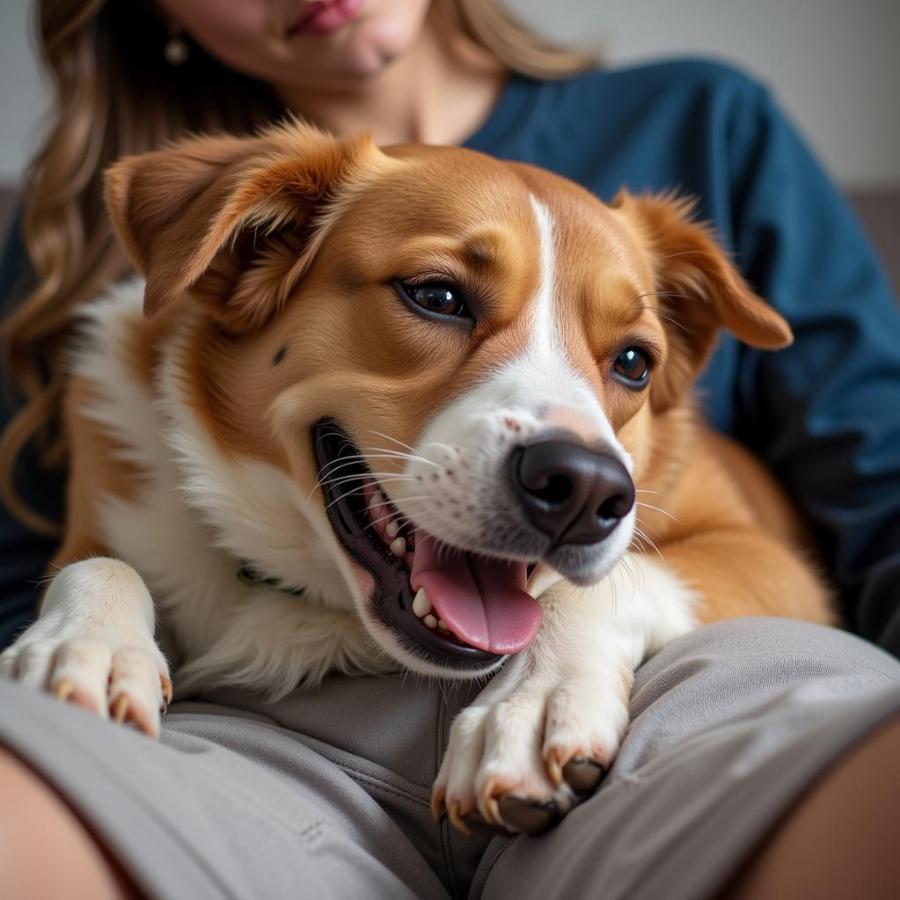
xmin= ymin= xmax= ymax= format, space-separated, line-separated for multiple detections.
xmin=0 ymin=557 xmax=172 ymax=736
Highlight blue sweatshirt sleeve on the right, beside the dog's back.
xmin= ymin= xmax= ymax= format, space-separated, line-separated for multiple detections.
xmin=730 ymin=90 xmax=900 ymax=655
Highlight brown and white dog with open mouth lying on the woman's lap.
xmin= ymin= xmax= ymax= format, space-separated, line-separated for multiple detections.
xmin=0 ymin=124 xmax=831 ymax=831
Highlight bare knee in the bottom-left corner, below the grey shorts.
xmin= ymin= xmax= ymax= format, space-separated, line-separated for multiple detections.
xmin=0 ymin=747 xmax=136 ymax=900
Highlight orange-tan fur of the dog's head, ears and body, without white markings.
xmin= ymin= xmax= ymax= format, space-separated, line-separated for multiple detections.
xmin=57 ymin=126 xmax=833 ymax=644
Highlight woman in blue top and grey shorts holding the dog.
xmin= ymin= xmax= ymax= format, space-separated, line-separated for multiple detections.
xmin=0 ymin=0 xmax=900 ymax=898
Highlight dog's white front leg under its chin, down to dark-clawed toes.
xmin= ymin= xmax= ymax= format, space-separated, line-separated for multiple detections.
xmin=432 ymin=554 xmax=695 ymax=834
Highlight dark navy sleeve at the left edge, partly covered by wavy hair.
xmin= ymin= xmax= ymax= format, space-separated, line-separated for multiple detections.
xmin=0 ymin=211 xmax=63 ymax=650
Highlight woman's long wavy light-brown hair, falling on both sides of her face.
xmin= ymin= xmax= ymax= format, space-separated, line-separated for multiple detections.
xmin=0 ymin=0 xmax=592 ymax=533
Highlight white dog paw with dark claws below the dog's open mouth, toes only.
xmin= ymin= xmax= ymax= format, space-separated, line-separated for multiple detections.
xmin=432 ymin=675 xmax=631 ymax=834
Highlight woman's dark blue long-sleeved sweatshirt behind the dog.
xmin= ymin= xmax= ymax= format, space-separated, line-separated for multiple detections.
xmin=0 ymin=61 xmax=900 ymax=655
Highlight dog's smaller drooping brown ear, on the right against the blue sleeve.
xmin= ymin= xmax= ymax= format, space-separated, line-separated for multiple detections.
xmin=612 ymin=191 xmax=793 ymax=409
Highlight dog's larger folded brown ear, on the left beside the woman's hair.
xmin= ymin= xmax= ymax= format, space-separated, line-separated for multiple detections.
xmin=106 ymin=123 xmax=387 ymax=330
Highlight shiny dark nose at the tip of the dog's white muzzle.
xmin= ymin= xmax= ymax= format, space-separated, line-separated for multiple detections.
xmin=509 ymin=439 xmax=634 ymax=545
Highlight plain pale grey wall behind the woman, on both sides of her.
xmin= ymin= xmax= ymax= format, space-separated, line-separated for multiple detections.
xmin=0 ymin=0 xmax=900 ymax=187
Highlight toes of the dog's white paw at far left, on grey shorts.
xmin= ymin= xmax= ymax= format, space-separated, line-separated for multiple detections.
xmin=0 ymin=620 xmax=172 ymax=737
